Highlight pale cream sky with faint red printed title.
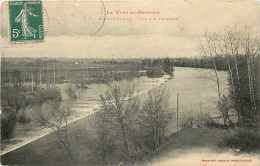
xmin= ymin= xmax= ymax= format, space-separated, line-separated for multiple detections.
xmin=0 ymin=0 xmax=260 ymax=58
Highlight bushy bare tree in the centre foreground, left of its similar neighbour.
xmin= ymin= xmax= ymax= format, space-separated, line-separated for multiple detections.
xmin=100 ymin=81 xmax=138 ymax=157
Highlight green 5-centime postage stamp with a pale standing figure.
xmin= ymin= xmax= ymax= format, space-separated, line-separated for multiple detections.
xmin=9 ymin=0 xmax=44 ymax=42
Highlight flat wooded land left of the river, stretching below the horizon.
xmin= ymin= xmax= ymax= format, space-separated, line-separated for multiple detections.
xmin=1 ymin=58 xmax=174 ymax=88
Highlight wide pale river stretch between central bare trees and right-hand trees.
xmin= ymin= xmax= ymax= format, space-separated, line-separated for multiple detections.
xmin=166 ymin=67 xmax=228 ymax=134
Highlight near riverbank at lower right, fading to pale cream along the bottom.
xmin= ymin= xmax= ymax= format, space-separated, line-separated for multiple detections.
xmin=142 ymin=127 xmax=260 ymax=166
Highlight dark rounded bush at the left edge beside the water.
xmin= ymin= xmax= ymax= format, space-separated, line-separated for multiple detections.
xmin=1 ymin=109 xmax=16 ymax=139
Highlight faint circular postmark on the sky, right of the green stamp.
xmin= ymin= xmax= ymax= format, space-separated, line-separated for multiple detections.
xmin=40 ymin=0 xmax=106 ymax=36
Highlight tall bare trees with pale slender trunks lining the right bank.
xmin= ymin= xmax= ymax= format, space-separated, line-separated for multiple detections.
xmin=201 ymin=28 xmax=260 ymax=124
